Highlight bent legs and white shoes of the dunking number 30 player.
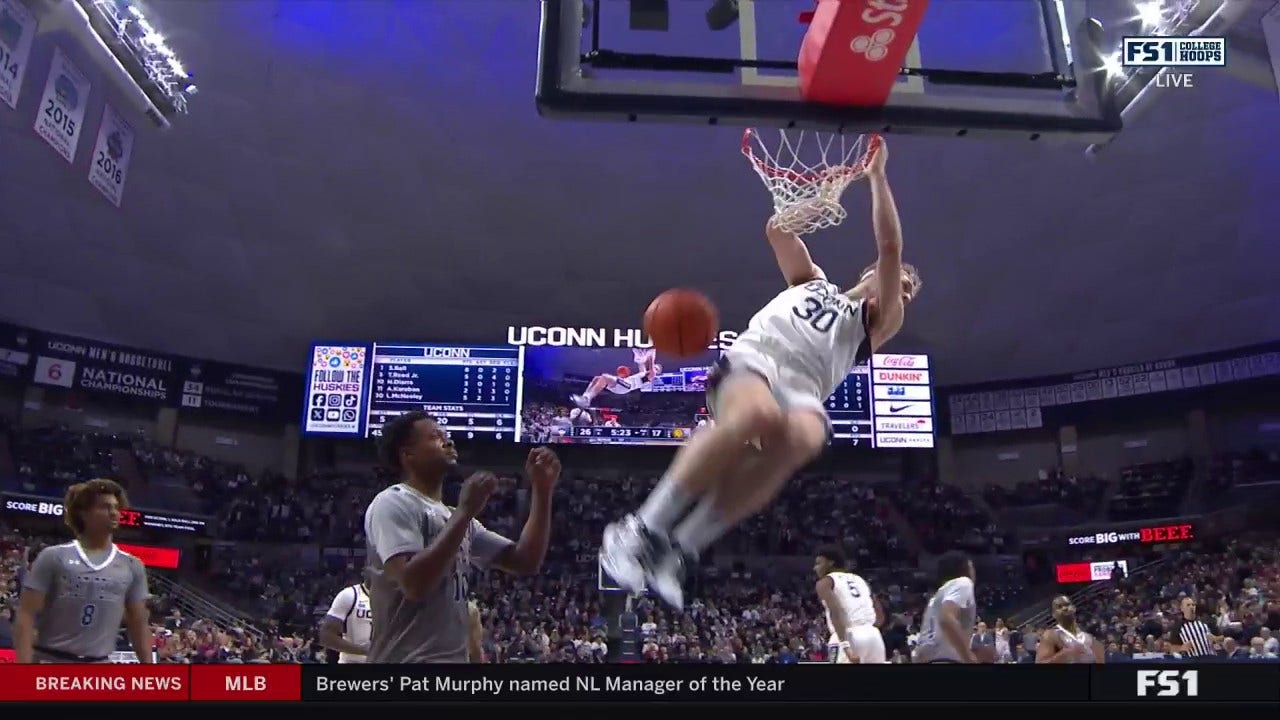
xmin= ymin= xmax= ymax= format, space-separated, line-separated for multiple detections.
xmin=600 ymin=368 xmax=827 ymax=607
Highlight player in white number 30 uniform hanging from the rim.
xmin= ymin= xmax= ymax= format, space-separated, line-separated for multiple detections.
xmin=600 ymin=135 xmax=920 ymax=607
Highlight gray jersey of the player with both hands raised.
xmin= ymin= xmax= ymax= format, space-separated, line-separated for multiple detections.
xmin=365 ymin=484 xmax=512 ymax=664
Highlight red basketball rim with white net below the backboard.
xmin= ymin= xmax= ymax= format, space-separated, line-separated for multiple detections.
xmin=742 ymin=128 xmax=879 ymax=234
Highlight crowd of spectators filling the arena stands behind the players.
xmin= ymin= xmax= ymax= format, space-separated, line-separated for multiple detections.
xmin=0 ymin=420 xmax=1280 ymax=662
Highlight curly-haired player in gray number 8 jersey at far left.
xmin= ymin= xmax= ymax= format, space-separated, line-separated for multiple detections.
xmin=13 ymin=479 xmax=152 ymax=662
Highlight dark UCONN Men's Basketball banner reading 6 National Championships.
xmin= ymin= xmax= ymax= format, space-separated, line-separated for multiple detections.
xmin=32 ymin=334 xmax=177 ymax=404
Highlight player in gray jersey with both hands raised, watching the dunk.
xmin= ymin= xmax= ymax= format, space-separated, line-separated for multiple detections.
xmin=365 ymin=413 xmax=561 ymax=662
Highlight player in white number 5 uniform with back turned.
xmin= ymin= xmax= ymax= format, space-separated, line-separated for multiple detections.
xmin=813 ymin=546 xmax=886 ymax=664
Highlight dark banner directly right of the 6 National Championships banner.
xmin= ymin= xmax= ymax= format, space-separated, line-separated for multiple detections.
xmin=174 ymin=359 xmax=302 ymax=420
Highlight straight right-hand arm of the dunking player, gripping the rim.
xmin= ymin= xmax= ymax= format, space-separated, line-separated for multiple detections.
xmin=867 ymin=138 xmax=904 ymax=347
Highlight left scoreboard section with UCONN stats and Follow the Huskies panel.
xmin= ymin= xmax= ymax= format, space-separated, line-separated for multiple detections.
xmin=302 ymin=343 xmax=524 ymax=441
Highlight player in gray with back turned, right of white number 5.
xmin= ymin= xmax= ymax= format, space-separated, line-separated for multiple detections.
xmin=915 ymin=551 xmax=979 ymax=662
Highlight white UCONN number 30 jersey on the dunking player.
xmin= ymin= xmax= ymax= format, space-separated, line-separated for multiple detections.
xmin=739 ymin=281 xmax=870 ymax=392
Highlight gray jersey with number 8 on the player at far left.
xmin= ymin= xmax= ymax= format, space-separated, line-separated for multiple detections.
xmin=23 ymin=542 xmax=151 ymax=661
